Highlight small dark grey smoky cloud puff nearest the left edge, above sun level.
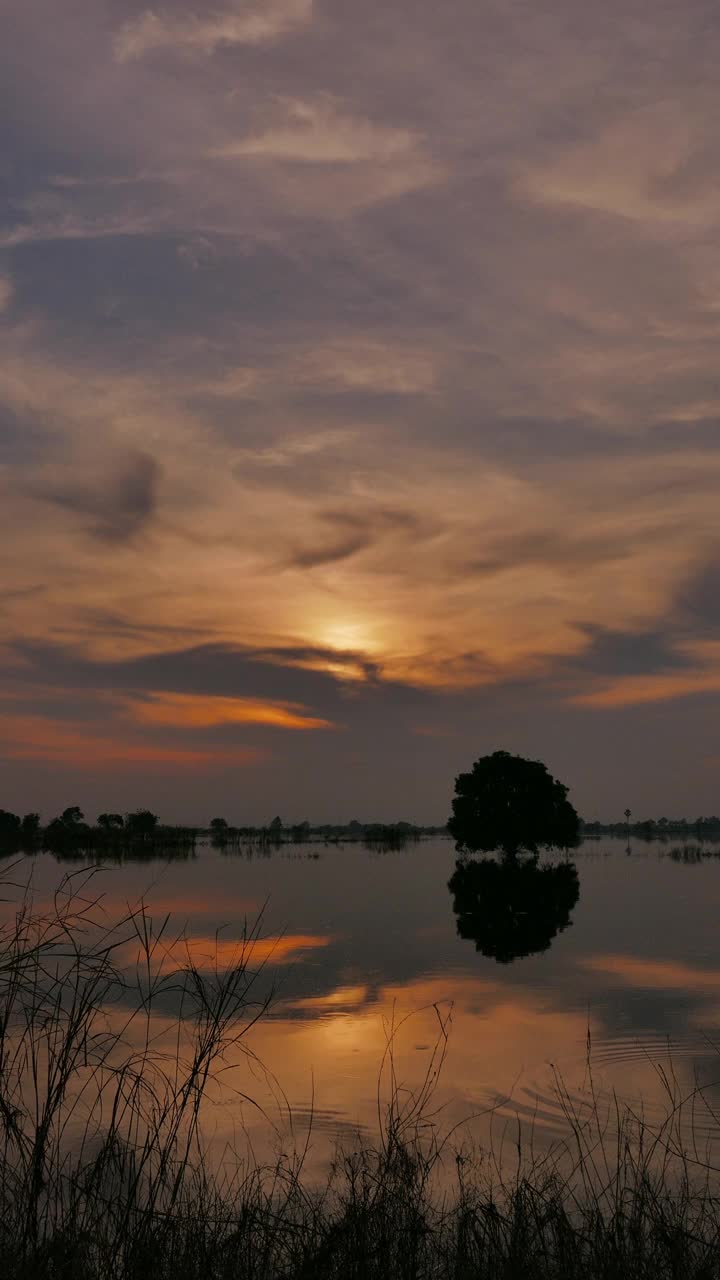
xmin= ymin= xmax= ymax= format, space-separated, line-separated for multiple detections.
xmin=38 ymin=451 xmax=160 ymax=543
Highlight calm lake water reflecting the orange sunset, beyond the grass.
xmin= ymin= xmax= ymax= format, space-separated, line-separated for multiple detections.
xmin=5 ymin=838 xmax=720 ymax=1172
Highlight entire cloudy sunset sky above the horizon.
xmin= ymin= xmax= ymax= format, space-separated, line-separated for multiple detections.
xmin=0 ymin=0 xmax=720 ymax=823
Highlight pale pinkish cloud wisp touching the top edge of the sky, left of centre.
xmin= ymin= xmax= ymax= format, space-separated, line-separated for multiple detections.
xmin=115 ymin=0 xmax=313 ymax=61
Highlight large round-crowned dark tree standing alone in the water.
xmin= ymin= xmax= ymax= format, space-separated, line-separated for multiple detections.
xmin=447 ymin=751 xmax=579 ymax=858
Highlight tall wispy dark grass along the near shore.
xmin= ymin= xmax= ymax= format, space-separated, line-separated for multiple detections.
xmin=0 ymin=873 xmax=720 ymax=1280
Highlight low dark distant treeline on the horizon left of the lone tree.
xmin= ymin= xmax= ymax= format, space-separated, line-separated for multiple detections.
xmin=0 ymin=805 xmax=445 ymax=858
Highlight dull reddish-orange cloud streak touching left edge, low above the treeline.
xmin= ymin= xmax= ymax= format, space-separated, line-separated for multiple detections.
xmin=0 ymin=716 xmax=268 ymax=769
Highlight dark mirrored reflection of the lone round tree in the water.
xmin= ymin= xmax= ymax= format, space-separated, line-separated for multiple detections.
xmin=447 ymin=858 xmax=580 ymax=964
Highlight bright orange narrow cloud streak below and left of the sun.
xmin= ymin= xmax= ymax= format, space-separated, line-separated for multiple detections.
xmin=127 ymin=692 xmax=334 ymax=730
